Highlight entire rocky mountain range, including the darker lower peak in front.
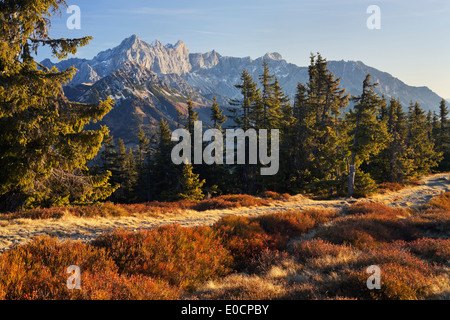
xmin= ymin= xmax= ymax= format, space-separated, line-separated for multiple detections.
xmin=41 ymin=35 xmax=442 ymax=144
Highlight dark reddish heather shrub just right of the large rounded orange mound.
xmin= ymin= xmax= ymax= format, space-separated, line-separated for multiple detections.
xmin=213 ymin=216 xmax=280 ymax=269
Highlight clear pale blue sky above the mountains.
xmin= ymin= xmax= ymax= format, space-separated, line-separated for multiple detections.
xmin=39 ymin=0 xmax=450 ymax=98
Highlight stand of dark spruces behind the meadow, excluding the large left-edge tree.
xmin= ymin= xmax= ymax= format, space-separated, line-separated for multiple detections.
xmin=93 ymin=54 xmax=449 ymax=203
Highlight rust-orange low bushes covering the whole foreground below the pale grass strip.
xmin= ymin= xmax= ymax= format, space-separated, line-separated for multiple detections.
xmin=0 ymin=195 xmax=450 ymax=299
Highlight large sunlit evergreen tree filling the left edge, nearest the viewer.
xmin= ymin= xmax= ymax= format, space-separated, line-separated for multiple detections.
xmin=0 ymin=0 xmax=113 ymax=210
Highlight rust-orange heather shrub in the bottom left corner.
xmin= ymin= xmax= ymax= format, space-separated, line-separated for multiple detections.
xmin=0 ymin=236 xmax=117 ymax=300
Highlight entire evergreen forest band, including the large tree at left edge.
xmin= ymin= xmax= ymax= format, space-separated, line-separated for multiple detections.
xmin=0 ymin=0 xmax=450 ymax=211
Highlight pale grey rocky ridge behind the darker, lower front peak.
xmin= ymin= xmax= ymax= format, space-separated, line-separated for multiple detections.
xmin=42 ymin=34 xmax=442 ymax=110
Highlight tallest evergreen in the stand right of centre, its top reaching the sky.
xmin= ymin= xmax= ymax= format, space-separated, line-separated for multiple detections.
xmin=294 ymin=54 xmax=349 ymax=194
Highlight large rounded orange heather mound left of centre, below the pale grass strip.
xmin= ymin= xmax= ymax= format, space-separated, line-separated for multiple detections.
xmin=93 ymin=224 xmax=232 ymax=289
